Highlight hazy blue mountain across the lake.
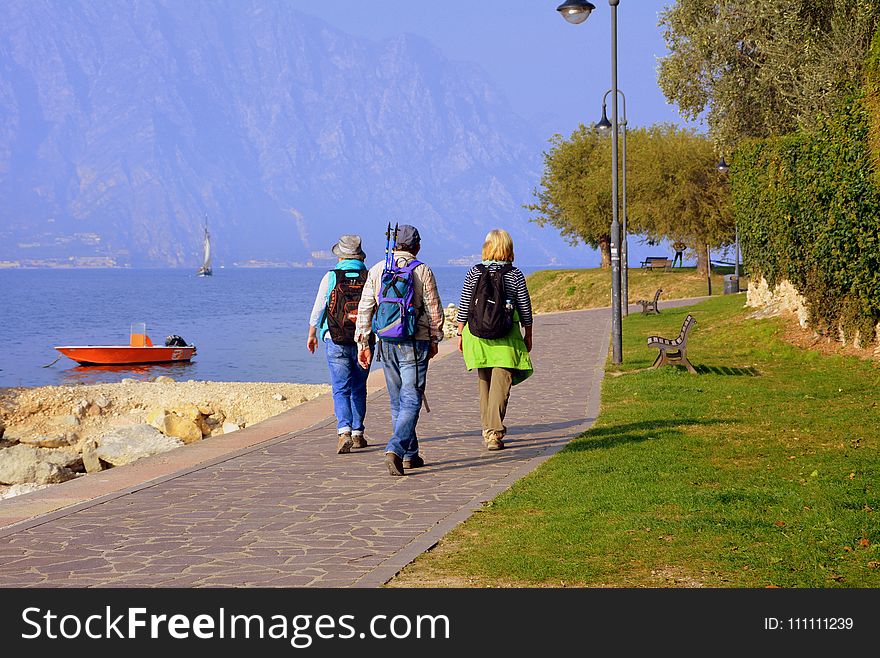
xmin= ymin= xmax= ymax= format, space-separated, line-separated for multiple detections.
xmin=0 ymin=0 xmax=584 ymax=269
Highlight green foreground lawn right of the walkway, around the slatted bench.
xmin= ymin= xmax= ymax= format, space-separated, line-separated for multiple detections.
xmin=390 ymin=295 xmax=880 ymax=588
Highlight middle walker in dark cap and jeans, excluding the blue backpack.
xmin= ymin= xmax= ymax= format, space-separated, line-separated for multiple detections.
xmin=355 ymin=224 xmax=444 ymax=475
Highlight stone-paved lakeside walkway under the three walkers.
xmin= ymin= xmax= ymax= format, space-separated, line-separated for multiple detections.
xmin=0 ymin=309 xmax=610 ymax=587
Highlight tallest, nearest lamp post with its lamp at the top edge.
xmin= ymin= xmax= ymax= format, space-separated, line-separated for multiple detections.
xmin=556 ymin=0 xmax=623 ymax=365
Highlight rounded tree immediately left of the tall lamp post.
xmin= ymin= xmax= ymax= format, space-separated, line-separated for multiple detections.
xmin=525 ymin=125 xmax=612 ymax=268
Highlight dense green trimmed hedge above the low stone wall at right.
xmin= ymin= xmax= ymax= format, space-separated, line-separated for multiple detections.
xmin=730 ymin=95 xmax=880 ymax=344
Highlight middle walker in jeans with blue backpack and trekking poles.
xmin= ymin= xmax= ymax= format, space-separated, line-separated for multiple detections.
xmin=356 ymin=224 xmax=444 ymax=476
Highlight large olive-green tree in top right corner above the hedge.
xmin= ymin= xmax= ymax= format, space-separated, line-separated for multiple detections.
xmin=658 ymin=0 xmax=880 ymax=152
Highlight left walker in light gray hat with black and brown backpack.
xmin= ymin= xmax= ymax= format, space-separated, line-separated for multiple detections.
xmin=306 ymin=235 xmax=370 ymax=455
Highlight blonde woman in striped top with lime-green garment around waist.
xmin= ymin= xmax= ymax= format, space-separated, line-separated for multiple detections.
xmin=456 ymin=229 xmax=533 ymax=450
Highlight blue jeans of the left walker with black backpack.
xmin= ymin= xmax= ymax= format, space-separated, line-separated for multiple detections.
xmin=324 ymin=338 xmax=370 ymax=434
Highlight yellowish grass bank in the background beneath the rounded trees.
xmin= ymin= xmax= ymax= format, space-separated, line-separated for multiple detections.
xmin=527 ymin=267 xmax=748 ymax=313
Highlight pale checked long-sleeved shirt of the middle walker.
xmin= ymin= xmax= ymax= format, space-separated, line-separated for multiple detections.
xmin=354 ymin=251 xmax=445 ymax=348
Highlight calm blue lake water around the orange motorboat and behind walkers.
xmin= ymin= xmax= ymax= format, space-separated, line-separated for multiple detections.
xmin=0 ymin=267 xmax=534 ymax=387
